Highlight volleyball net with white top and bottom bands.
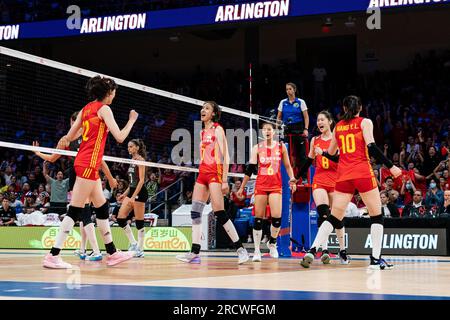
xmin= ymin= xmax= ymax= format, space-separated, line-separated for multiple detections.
xmin=0 ymin=47 xmax=268 ymax=180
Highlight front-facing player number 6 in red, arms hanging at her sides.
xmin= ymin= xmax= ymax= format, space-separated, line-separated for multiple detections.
xmin=238 ymin=122 xmax=297 ymax=262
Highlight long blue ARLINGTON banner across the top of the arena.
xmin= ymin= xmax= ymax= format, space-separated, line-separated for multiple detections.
xmin=0 ymin=0 xmax=450 ymax=41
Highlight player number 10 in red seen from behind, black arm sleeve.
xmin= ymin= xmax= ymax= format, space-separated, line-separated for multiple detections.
xmin=300 ymin=96 xmax=401 ymax=270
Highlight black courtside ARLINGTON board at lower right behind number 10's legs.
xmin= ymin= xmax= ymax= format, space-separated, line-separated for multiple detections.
xmin=342 ymin=228 xmax=447 ymax=256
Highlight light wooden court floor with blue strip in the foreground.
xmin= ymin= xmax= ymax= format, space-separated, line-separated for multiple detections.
xmin=0 ymin=250 xmax=450 ymax=300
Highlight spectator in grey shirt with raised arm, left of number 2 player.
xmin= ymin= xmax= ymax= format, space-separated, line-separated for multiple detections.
xmin=40 ymin=161 xmax=69 ymax=215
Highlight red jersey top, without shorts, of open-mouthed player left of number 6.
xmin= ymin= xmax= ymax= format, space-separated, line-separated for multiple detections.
xmin=199 ymin=123 xmax=223 ymax=176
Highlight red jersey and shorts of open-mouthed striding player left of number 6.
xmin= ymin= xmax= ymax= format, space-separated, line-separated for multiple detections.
xmin=197 ymin=123 xmax=223 ymax=186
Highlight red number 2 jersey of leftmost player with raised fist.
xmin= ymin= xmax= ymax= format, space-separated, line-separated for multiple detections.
xmin=74 ymin=101 xmax=108 ymax=171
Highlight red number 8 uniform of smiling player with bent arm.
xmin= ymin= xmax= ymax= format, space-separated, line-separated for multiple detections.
xmin=313 ymin=136 xmax=338 ymax=187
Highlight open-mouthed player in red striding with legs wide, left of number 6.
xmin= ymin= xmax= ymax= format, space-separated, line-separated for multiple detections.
xmin=177 ymin=101 xmax=248 ymax=264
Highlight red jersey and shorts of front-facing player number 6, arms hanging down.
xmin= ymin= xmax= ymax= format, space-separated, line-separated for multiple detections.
xmin=255 ymin=142 xmax=283 ymax=190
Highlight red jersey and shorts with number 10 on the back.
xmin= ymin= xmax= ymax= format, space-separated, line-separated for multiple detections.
xmin=335 ymin=117 xmax=377 ymax=194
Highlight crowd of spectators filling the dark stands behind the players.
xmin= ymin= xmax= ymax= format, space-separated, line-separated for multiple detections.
xmin=0 ymin=51 xmax=450 ymax=223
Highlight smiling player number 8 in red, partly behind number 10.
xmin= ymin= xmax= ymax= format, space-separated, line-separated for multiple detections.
xmin=302 ymin=111 xmax=349 ymax=264
